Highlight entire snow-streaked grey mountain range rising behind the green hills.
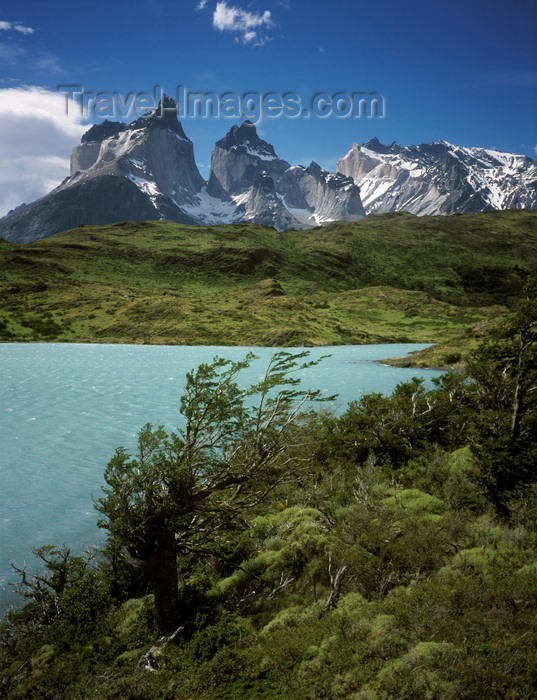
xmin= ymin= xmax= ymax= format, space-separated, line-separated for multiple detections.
xmin=0 ymin=98 xmax=537 ymax=243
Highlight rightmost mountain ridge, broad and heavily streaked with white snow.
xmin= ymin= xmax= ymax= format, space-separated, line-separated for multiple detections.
xmin=337 ymin=139 xmax=537 ymax=215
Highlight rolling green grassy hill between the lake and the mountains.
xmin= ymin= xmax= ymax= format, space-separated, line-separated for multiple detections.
xmin=0 ymin=210 xmax=537 ymax=364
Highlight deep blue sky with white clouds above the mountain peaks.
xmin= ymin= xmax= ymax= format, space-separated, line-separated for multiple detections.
xmin=0 ymin=0 xmax=537 ymax=214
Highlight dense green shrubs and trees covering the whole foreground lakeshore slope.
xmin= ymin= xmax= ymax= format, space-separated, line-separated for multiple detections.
xmin=0 ymin=285 xmax=537 ymax=700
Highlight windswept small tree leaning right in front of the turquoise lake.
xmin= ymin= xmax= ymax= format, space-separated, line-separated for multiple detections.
xmin=95 ymin=352 xmax=334 ymax=632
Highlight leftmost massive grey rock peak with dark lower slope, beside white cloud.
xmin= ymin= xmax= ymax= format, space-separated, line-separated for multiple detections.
xmin=0 ymin=97 xmax=205 ymax=243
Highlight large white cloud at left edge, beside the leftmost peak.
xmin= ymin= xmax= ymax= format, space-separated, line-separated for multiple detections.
xmin=0 ymin=86 xmax=88 ymax=216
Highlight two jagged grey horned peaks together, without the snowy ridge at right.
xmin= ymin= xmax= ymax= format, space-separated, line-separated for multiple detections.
xmin=0 ymin=106 xmax=363 ymax=242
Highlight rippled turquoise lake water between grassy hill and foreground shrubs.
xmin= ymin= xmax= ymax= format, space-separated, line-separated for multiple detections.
xmin=0 ymin=343 xmax=441 ymax=614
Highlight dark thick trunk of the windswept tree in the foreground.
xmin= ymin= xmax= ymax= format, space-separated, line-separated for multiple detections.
xmin=148 ymin=533 xmax=179 ymax=634
